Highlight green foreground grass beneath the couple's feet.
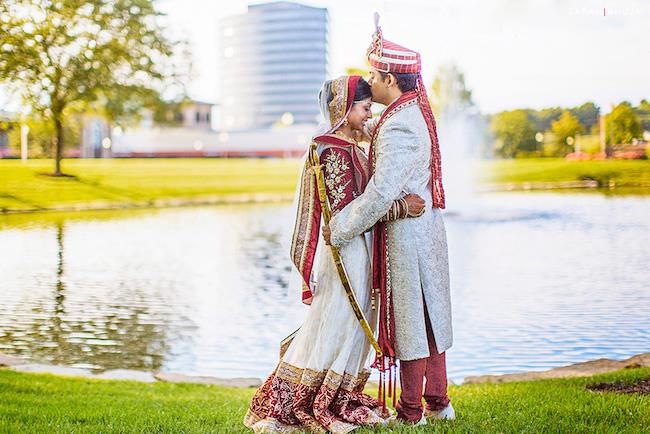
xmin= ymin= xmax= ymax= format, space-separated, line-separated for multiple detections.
xmin=0 ymin=368 xmax=650 ymax=433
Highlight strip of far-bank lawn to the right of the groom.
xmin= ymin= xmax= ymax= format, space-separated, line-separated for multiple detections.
xmin=483 ymin=158 xmax=650 ymax=189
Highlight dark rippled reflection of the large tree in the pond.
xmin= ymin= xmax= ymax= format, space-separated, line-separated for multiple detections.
xmin=0 ymin=212 xmax=175 ymax=370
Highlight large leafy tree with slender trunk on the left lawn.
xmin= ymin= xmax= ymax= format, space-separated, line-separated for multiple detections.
xmin=0 ymin=0 xmax=184 ymax=176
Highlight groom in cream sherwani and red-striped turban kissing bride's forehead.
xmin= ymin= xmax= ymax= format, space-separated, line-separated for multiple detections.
xmin=323 ymin=19 xmax=455 ymax=425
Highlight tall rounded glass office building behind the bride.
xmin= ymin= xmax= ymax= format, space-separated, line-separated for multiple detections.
xmin=219 ymin=2 xmax=328 ymax=130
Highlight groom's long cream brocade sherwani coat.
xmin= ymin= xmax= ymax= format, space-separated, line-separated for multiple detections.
xmin=330 ymin=100 xmax=453 ymax=360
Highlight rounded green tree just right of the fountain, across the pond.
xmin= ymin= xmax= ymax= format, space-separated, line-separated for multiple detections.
xmin=490 ymin=109 xmax=536 ymax=158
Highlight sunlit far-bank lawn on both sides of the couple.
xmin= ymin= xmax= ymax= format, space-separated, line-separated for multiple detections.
xmin=0 ymin=159 xmax=650 ymax=212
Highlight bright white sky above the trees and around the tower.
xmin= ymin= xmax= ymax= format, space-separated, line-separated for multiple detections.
xmin=153 ymin=0 xmax=650 ymax=113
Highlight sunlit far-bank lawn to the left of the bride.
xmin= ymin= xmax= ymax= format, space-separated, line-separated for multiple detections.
xmin=0 ymin=159 xmax=300 ymax=210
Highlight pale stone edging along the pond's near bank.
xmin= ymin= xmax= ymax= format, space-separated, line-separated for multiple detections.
xmin=0 ymin=352 xmax=650 ymax=389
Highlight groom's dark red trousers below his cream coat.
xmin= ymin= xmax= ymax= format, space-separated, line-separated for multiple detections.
xmin=397 ymin=306 xmax=449 ymax=423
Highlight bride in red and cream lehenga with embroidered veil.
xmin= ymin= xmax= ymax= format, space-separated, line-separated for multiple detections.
xmin=244 ymin=76 xmax=424 ymax=433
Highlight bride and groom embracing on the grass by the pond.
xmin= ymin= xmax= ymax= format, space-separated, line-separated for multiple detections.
xmin=244 ymin=18 xmax=455 ymax=433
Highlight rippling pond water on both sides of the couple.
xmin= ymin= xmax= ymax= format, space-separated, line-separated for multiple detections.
xmin=0 ymin=193 xmax=650 ymax=382
